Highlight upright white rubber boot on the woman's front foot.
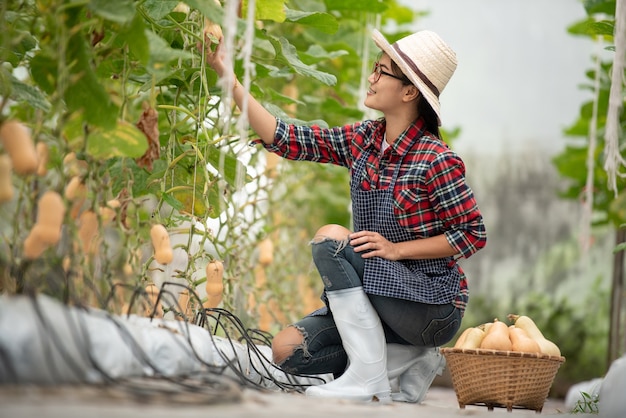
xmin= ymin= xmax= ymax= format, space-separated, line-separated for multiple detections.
xmin=306 ymin=287 xmax=391 ymax=403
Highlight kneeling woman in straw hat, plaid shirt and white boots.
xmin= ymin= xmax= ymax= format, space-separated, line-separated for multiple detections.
xmin=202 ymin=30 xmax=486 ymax=402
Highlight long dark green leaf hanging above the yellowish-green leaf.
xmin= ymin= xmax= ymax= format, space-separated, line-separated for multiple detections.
xmin=64 ymin=33 xmax=118 ymax=129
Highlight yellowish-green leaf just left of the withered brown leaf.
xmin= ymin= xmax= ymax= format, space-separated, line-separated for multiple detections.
xmin=87 ymin=121 xmax=148 ymax=160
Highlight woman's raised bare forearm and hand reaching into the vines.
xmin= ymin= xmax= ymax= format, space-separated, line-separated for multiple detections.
xmin=205 ymin=40 xmax=276 ymax=144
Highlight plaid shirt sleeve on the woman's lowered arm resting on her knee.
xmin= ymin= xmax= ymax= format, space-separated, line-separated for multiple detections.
xmin=427 ymin=151 xmax=487 ymax=258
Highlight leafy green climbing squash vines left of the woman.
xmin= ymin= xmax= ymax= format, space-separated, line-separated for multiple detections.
xmin=0 ymin=0 xmax=415 ymax=334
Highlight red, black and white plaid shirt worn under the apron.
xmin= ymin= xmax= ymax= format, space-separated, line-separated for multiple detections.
xmin=264 ymin=119 xmax=487 ymax=309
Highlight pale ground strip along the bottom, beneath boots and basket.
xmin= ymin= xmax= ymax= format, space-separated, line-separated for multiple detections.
xmin=0 ymin=385 xmax=590 ymax=418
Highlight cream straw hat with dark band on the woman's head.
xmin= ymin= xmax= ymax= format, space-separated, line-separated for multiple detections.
xmin=372 ymin=29 xmax=456 ymax=125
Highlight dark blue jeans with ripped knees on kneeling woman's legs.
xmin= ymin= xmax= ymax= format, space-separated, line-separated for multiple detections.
xmin=280 ymin=239 xmax=462 ymax=377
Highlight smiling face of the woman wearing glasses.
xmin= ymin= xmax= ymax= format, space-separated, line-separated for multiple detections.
xmin=364 ymin=54 xmax=404 ymax=113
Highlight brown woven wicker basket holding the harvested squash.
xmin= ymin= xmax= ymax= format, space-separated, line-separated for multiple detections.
xmin=441 ymin=348 xmax=565 ymax=413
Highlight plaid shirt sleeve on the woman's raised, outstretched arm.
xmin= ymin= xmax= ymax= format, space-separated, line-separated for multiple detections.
xmin=263 ymin=118 xmax=359 ymax=167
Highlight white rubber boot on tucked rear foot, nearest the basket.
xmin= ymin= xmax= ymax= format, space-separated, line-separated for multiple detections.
xmin=387 ymin=344 xmax=446 ymax=403
